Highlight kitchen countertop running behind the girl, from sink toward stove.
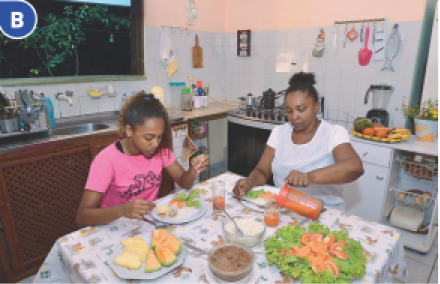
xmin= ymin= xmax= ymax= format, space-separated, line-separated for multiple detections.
xmin=0 ymin=101 xmax=240 ymax=155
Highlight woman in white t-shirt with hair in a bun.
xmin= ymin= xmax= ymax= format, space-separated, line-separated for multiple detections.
xmin=234 ymin=72 xmax=364 ymax=210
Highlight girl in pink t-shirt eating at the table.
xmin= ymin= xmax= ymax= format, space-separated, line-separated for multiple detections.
xmin=76 ymin=93 xmax=209 ymax=226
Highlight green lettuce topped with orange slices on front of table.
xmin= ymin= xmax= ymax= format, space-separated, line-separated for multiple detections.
xmin=264 ymin=223 xmax=366 ymax=283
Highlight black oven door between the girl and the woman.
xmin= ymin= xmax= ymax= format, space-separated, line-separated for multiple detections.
xmin=228 ymin=116 xmax=276 ymax=185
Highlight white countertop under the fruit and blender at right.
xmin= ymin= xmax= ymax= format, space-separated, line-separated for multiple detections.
xmin=350 ymin=133 xmax=438 ymax=156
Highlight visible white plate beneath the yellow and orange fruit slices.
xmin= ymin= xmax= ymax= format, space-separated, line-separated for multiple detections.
xmin=107 ymin=232 xmax=186 ymax=279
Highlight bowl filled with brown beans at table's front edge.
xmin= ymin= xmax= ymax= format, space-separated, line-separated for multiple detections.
xmin=209 ymin=244 xmax=254 ymax=281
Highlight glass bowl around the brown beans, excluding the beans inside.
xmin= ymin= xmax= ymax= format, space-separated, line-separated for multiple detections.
xmin=209 ymin=242 xmax=255 ymax=281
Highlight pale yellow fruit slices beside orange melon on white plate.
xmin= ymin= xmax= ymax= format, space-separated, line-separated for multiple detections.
xmin=113 ymin=238 xmax=150 ymax=270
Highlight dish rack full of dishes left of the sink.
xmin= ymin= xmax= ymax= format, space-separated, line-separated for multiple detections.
xmin=0 ymin=101 xmax=52 ymax=138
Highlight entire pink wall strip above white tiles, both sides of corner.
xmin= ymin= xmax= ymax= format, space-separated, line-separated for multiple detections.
xmin=145 ymin=0 xmax=426 ymax=32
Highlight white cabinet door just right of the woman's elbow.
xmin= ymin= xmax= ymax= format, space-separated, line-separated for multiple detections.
xmin=342 ymin=163 xmax=389 ymax=222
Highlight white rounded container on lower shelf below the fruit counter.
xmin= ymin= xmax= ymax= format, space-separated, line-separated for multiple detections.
xmin=390 ymin=204 xmax=426 ymax=232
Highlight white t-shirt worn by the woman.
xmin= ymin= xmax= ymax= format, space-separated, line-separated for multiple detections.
xmin=267 ymin=120 xmax=350 ymax=210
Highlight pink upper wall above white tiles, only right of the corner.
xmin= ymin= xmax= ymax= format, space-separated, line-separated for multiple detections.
xmin=225 ymin=0 xmax=426 ymax=32
